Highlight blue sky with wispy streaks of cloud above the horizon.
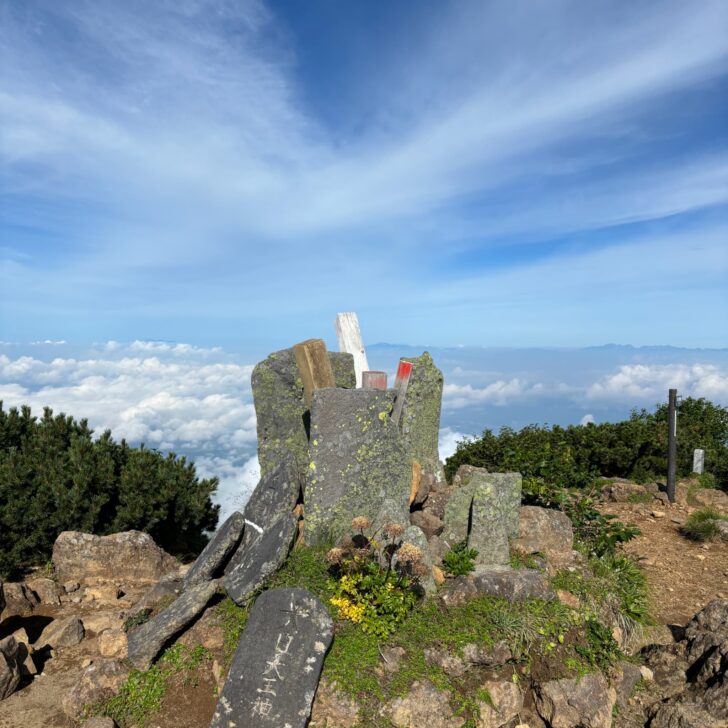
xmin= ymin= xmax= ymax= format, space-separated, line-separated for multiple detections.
xmin=0 ymin=0 xmax=728 ymax=351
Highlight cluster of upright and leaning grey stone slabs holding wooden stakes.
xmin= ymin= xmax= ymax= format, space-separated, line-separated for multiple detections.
xmin=122 ymin=314 xmax=528 ymax=728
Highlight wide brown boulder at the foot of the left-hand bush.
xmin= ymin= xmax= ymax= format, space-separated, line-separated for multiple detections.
xmin=53 ymin=531 xmax=179 ymax=583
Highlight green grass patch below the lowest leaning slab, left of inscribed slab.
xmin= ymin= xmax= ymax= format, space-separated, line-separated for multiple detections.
xmin=91 ymin=644 xmax=212 ymax=728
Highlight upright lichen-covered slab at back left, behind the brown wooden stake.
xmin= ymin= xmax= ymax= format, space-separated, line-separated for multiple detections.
xmin=251 ymin=349 xmax=356 ymax=480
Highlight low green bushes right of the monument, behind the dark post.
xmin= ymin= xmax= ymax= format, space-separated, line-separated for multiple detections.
xmin=445 ymin=397 xmax=728 ymax=489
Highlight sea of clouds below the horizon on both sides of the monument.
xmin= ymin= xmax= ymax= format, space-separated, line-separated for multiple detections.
xmin=0 ymin=341 xmax=728 ymax=518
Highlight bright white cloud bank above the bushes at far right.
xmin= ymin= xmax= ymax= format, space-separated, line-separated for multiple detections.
xmin=586 ymin=364 xmax=728 ymax=404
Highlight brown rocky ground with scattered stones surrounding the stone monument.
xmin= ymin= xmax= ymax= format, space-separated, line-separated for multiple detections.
xmin=0 ymin=474 xmax=728 ymax=728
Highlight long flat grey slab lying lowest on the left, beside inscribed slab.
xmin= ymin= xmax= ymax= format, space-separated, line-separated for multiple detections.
xmin=127 ymin=581 xmax=218 ymax=670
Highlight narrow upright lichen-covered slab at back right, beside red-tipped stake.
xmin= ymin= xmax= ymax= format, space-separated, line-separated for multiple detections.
xmin=400 ymin=352 xmax=444 ymax=478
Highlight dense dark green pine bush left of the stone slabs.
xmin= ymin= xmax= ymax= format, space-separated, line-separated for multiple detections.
xmin=0 ymin=402 xmax=218 ymax=578
